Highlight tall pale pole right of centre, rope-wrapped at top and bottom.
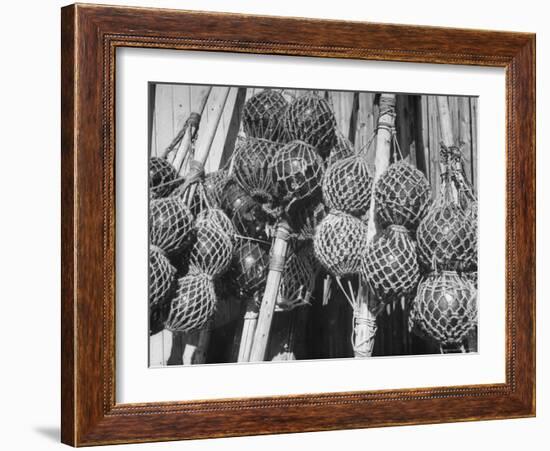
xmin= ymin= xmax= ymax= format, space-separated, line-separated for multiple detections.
xmin=354 ymin=94 xmax=395 ymax=357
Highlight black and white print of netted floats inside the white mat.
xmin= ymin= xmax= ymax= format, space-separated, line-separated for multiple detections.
xmin=149 ymin=82 xmax=483 ymax=367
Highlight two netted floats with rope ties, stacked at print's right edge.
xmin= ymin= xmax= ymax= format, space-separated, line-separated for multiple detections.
xmin=410 ymin=144 xmax=477 ymax=352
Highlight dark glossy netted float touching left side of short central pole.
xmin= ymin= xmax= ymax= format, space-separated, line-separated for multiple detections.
xmin=230 ymin=239 xmax=269 ymax=297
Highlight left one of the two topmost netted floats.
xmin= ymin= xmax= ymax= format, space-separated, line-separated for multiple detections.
xmin=242 ymin=89 xmax=288 ymax=141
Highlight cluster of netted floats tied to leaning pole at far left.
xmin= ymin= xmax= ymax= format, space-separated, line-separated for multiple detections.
xmin=149 ymin=88 xmax=239 ymax=360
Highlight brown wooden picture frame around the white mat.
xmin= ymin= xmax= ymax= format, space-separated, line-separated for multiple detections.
xmin=61 ymin=4 xmax=535 ymax=446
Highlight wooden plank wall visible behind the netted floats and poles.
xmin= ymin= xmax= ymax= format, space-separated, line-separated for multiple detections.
xmin=149 ymin=84 xmax=478 ymax=365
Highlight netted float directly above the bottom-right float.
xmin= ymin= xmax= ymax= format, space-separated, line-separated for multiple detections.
xmin=416 ymin=202 xmax=477 ymax=271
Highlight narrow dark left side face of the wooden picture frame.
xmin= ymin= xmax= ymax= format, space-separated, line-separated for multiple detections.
xmin=61 ymin=5 xmax=77 ymax=446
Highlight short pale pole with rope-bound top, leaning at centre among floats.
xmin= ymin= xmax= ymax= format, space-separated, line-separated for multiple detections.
xmin=250 ymin=220 xmax=290 ymax=362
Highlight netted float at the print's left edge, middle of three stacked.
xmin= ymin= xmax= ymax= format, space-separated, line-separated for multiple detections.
xmin=149 ymin=197 xmax=193 ymax=253
